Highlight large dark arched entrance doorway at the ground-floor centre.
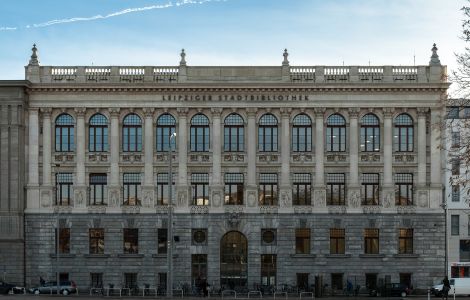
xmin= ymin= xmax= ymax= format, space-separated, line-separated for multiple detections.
xmin=220 ymin=231 xmax=248 ymax=290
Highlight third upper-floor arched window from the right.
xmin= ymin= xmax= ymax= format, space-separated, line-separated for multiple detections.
xmin=326 ymin=114 xmax=346 ymax=152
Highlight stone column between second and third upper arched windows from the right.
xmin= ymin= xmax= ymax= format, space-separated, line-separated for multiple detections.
xmin=348 ymin=108 xmax=361 ymax=207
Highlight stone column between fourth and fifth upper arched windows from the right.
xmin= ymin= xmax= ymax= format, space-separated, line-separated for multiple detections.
xmin=279 ymin=108 xmax=292 ymax=208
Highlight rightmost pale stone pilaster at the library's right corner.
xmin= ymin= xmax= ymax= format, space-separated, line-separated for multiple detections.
xmin=429 ymin=108 xmax=445 ymax=208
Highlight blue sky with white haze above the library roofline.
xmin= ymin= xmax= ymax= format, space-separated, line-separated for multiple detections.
xmin=0 ymin=0 xmax=467 ymax=79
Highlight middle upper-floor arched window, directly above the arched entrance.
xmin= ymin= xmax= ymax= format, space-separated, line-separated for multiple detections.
xmin=224 ymin=114 xmax=245 ymax=152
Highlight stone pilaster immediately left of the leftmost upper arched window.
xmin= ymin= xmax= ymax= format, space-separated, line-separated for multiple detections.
xmin=41 ymin=108 xmax=53 ymax=207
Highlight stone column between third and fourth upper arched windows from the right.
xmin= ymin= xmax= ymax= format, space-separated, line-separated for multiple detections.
xmin=313 ymin=107 xmax=326 ymax=207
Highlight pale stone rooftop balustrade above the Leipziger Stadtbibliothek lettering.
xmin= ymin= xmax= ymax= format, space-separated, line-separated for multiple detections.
xmin=27 ymin=66 xmax=447 ymax=84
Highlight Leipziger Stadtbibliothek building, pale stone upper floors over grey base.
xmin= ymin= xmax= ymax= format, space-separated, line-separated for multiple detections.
xmin=12 ymin=47 xmax=448 ymax=289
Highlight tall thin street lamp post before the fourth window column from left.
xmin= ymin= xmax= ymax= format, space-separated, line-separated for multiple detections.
xmin=166 ymin=132 xmax=176 ymax=297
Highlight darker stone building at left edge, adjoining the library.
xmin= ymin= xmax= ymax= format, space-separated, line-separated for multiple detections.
xmin=0 ymin=80 xmax=27 ymax=285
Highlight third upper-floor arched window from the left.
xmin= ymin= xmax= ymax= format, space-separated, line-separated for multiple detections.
xmin=122 ymin=114 xmax=142 ymax=152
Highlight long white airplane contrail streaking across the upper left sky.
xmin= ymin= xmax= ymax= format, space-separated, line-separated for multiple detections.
xmin=0 ymin=0 xmax=228 ymax=31
